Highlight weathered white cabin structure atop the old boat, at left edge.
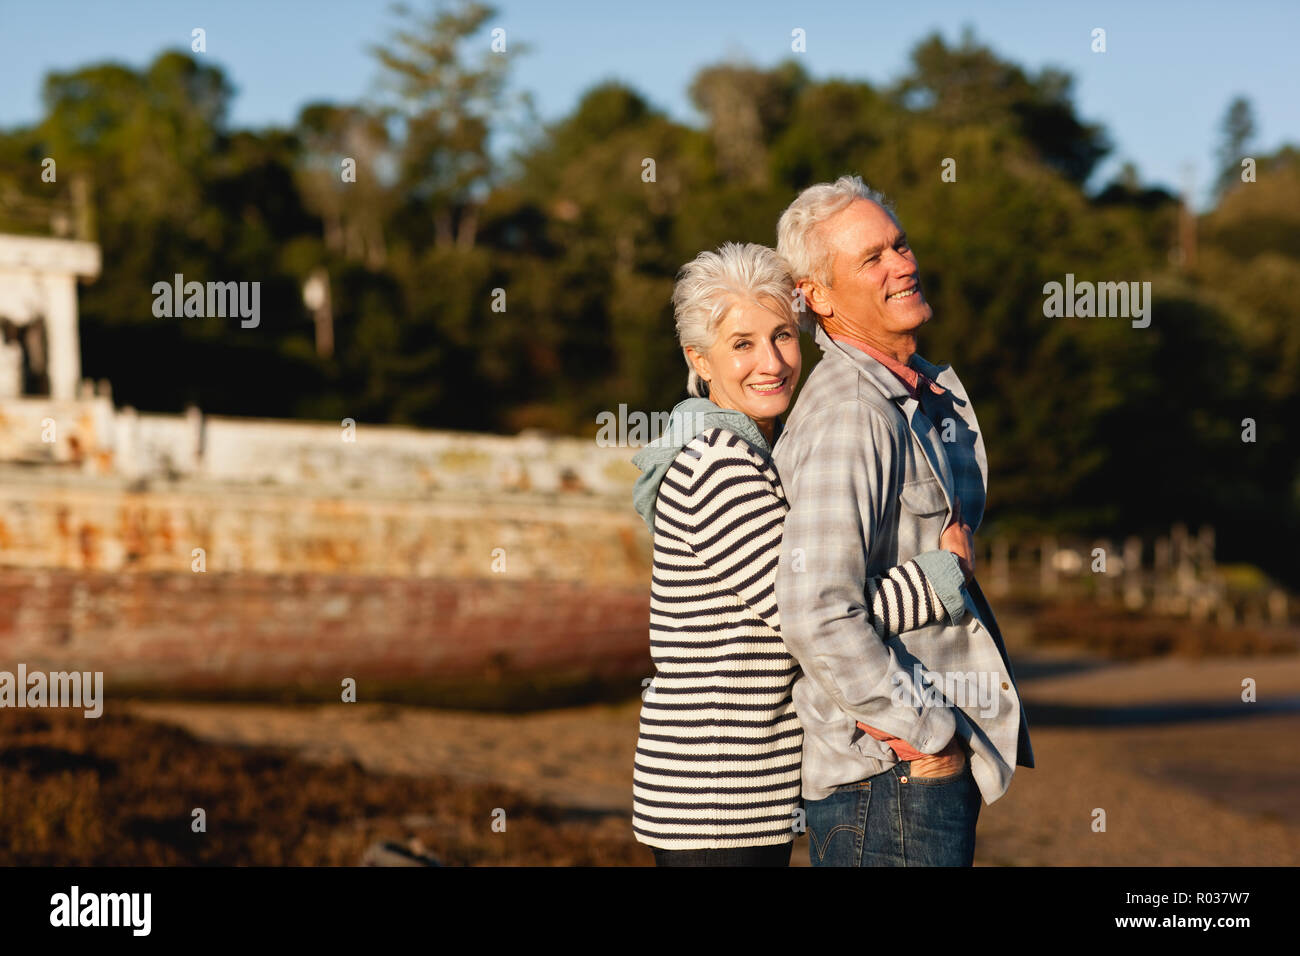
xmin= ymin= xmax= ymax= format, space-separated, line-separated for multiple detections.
xmin=0 ymin=235 xmax=100 ymax=401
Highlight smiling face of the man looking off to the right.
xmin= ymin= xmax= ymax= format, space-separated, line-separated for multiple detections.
xmin=806 ymin=199 xmax=933 ymax=341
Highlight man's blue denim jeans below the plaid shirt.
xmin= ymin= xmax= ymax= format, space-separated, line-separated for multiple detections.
xmin=805 ymin=754 xmax=982 ymax=866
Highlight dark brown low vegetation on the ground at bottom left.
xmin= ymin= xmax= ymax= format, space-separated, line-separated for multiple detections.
xmin=0 ymin=710 xmax=650 ymax=866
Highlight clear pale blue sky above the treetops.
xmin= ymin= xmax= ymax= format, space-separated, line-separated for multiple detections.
xmin=0 ymin=0 xmax=1300 ymax=207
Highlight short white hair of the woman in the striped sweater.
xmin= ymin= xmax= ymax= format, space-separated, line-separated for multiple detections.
xmin=672 ymin=242 xmax=797 ymax=398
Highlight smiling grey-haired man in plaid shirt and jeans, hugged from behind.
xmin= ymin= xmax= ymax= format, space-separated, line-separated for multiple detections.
xmin=775 ymin=177 xmax=1034 ymax=866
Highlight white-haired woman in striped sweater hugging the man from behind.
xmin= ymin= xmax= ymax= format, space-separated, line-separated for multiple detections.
xmin=632 ymin=243 xmax=967 ymax=866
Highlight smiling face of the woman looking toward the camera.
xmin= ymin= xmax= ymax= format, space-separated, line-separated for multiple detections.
xmin=686 ymin=298 xmax=801 ymax=424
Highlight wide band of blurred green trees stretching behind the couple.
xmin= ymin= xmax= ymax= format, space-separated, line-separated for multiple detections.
xmin=0 ymin=22 xmax=1300 ymax=579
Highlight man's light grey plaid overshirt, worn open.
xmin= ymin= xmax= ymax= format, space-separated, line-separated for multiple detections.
xmin=774 ymin=328 xmax=1034 ymax=803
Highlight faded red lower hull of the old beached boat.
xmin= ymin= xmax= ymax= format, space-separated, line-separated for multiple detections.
xmin=0 ymin=570 xmax=653 ymax=708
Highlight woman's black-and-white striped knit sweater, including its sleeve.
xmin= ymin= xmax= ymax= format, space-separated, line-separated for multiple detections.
xmin=633 ymin=428 xmax=944 ymax=849
